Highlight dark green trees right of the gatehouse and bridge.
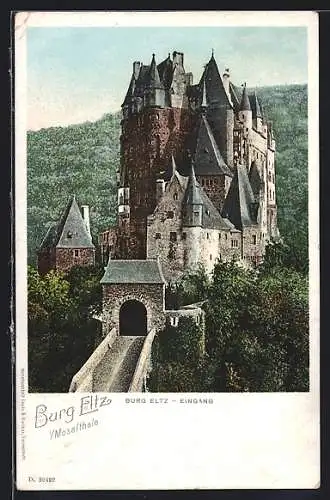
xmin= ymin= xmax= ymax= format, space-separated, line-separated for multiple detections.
xmin=150 ymin=260 xmax=309 ymax=392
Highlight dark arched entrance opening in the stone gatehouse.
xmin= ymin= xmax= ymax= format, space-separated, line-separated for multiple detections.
xmin=119 ymin=300 xmax=147 ymax=337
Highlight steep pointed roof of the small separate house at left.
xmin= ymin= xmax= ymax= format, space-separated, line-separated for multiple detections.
xmin=40 ymin=196 xmax=94 ymax=249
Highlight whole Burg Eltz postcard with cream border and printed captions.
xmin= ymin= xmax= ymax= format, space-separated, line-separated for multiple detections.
xmin=14 ymin=11 xmax=320 ymax=490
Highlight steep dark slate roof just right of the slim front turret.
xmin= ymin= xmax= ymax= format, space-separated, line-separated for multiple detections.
xmin=221 ymin=165 xmax=257 ymax=230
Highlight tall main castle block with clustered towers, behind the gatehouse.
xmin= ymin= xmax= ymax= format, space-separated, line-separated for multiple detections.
xmin=100 ymin=51 xmax=278 ymax=281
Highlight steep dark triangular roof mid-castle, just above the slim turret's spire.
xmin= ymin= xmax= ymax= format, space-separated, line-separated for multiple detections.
xmin=195 ymin=115 xmax=232 ymax=177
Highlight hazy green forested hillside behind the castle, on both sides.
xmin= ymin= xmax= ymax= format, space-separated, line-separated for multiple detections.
xmin=27 ymin=85 xmax=308 ymax=265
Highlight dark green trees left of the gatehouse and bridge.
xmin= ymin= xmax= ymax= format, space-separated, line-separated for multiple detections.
xmin=28 ymin=266 xmax=101 ymax=392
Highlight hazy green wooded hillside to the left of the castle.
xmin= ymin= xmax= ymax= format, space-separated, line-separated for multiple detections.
xmin=27 ymin=114 xmax=120 ymax=264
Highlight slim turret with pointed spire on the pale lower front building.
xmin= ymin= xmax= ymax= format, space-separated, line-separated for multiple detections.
xmin=183 ymin=161 xmax=203 ymax=227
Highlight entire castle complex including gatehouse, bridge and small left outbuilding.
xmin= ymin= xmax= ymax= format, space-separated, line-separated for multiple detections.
xmin=38 ymin=47 xmax=278 ymax=392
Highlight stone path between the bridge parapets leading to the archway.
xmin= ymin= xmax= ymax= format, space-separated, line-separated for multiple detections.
xmin=93 ymin=336 xmax=145 ymax=392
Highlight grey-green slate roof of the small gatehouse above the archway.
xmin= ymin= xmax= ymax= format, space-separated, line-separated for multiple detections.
xmin=100 ymin=259 xmax=166 ymax=284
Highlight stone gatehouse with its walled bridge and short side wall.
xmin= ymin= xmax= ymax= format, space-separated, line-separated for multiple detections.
xmin=69 ymin=259 xmax=204 ymax=392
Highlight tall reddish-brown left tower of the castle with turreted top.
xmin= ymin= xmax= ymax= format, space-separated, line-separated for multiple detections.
xmin=120 ymin=52 xmax=193 ymax=259
